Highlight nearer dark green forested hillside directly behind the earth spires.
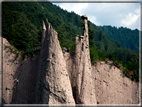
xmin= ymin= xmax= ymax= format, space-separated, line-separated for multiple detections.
xmin=2 ymin=2 xmax=139 ymax=80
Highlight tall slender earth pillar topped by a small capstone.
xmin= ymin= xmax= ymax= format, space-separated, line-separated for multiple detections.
xmin=75 ymin=15 xmax=97 ymax=104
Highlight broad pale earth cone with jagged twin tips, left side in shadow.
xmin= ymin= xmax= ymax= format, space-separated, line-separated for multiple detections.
xmin=35 ymin=20 xmax=75 ymax=104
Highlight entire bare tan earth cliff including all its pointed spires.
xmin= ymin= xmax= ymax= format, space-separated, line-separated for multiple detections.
xmin=2 ymin=16 xmax=139 ymax=105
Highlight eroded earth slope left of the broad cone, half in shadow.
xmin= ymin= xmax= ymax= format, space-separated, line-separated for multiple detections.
xmin=2 ymin=38 xmax=38 ymax=104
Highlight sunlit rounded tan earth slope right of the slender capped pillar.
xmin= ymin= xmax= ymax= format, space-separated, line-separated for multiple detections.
xmin=92 ymin=62 xmax=139 ymax=104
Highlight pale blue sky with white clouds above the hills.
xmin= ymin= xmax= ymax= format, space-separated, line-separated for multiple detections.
xmin=53 ymin=0 xmax=140 ymax=29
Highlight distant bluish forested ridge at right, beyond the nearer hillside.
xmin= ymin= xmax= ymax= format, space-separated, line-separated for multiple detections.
xmin=98 ymin=26 xmax=139 ymax=51
